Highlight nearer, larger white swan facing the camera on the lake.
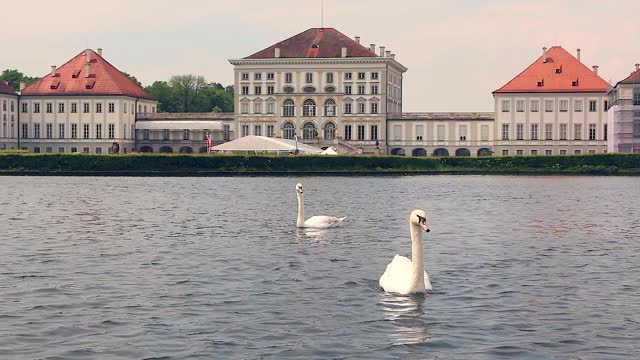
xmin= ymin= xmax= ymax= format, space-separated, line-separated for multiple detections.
xmin=380 ymin=210 xmax=431 ymax=295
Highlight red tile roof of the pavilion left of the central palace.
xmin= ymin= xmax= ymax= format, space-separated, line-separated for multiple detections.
xmin=22 ymin=49 xmax=155 ymax=100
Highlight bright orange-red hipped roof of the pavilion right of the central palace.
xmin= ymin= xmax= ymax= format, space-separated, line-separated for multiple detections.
xmin=494 ymin=46 xmax=611 ymax=94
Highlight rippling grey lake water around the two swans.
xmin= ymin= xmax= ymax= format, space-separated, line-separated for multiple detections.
xmin=0 ymin=176 xmax=640 ymax=359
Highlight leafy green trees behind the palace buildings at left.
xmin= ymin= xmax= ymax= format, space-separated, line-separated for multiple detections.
xmin=0 ymin=69 xmax=234 ymax=112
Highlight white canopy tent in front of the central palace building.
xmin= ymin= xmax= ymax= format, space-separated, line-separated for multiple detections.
xmin=211 ymin=135 xmax=322 ymax=154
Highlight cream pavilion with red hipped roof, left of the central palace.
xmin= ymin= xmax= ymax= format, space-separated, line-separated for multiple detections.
xmin=19 ymin=49 xmax=157 ymax=154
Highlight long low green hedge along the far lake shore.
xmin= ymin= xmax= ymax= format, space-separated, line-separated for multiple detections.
xmin=0 ymin=153 xmax=640 ymax=174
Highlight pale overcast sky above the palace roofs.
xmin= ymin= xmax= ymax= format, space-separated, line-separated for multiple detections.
xmin=0 ymin=0 xmax=640 ymax=112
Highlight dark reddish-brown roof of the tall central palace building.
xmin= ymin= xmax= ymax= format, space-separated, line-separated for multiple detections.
xmin=245 ymin=28 xmax=378 ymax=59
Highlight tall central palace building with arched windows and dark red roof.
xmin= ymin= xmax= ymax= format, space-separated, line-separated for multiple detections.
xmin=229 ymin=28 xmax=407 ymax=153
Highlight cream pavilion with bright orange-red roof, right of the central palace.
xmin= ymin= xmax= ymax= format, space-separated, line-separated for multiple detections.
xmin=492 ymin=46 xmax=611 ymax=155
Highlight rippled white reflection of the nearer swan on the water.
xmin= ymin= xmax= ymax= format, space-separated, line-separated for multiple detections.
xmin=379 ymin=293 xmax=431 ymax=345
